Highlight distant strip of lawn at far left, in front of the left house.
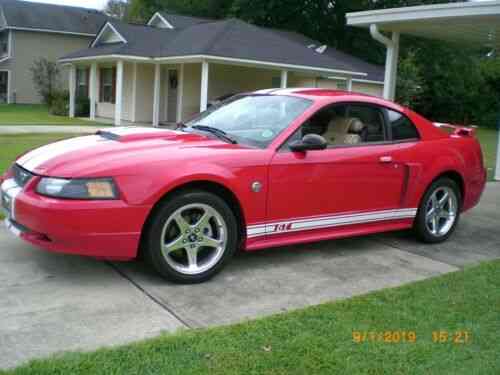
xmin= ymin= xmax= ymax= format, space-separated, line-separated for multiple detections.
xmin=0 ymin=104 xmax=103 ymax=126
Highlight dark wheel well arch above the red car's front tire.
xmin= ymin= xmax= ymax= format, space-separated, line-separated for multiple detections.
xmin=139 ymin=181 xmax=246 ymax=256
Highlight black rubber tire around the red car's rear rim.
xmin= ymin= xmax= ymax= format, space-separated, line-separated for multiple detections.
xmin=413 ymin=177 xmax=462 ymax=244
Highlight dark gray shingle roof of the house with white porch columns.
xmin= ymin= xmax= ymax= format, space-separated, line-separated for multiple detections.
xmin=60 ymin=19 xmax=383 ymax=81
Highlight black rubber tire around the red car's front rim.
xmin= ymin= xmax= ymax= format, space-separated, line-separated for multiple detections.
xmin=143 ymin=190 xmax=239 ymax=284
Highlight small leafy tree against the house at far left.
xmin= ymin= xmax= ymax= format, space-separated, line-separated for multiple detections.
xmin=30 ymin=57 xmax=60 ymax=106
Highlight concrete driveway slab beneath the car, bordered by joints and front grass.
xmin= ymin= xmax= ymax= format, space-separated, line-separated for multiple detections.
xmin=114 ymin=237 xmax=456 ymax=327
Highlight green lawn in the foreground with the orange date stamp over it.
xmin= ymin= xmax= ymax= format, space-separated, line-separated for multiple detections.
xmin=1 ymin=261 xmax=500 ymax=375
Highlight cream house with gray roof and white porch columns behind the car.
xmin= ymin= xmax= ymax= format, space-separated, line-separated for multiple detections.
xmin=60 ymin=13 xmax=384 ymax=126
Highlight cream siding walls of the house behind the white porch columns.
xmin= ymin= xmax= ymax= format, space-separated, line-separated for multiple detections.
xmin=90 ymin=63 xmax=383 ymax=123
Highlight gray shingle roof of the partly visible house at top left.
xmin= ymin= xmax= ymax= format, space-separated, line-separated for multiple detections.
xmin=0 ymin=0 xmax=109 ymax=35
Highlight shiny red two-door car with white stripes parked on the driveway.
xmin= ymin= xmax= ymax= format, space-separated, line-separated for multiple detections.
xmin=1 ymin=89 xmax=486 ymax=283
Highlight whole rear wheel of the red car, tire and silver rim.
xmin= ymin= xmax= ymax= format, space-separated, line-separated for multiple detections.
xmin=414 ymin=178 xmax=462 ymax=243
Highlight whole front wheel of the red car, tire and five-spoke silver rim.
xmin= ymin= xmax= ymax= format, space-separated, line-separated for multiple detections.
xmin=145 ymin=191 xmax=238 ymax=283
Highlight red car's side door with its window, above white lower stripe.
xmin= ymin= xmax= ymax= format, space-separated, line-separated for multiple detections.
xmin=267 ymin=103 xmax=405 ymax=232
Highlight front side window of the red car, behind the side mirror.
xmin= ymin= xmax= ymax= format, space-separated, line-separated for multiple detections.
xmin=287 ymin=104 xmax=386 ymax=147
